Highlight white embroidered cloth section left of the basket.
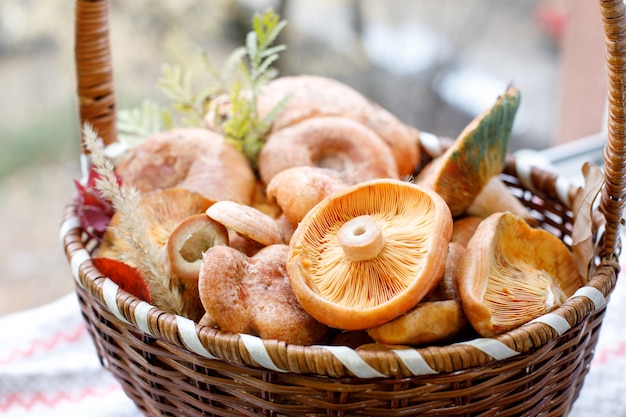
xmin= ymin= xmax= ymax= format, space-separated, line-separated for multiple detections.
xmin=0 ymin=294 xmax=143 ymax=417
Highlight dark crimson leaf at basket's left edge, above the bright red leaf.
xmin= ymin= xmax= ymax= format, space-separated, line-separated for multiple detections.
xmin=74 ymin=167 xmax=119 ymax=240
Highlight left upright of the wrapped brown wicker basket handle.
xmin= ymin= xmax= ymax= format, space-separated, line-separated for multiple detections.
xmin=74 ymin=0 xmax=117 ymax=152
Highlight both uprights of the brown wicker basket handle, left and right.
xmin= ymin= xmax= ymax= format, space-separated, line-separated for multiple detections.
xmin=75 ymin=0 xmax=626 ymax=257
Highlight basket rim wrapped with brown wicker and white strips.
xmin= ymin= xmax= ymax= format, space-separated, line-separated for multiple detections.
xmin=60 ymin=153 xmax=620 ymax=379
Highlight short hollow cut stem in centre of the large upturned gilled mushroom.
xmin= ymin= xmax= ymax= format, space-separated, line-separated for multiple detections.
xmin=337 ymin=215 xmax=385 ymax=262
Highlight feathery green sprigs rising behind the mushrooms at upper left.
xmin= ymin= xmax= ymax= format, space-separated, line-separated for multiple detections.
xmin=118 ymin=9 xmax=289 ymax=170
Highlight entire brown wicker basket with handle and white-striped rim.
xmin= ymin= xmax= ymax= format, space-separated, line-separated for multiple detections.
xmin=61 ymin=0 xmax=626 ymax=417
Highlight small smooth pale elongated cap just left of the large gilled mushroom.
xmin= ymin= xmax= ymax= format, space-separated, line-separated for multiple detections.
xmin=206 ymin=200 xmax=285 ymax=245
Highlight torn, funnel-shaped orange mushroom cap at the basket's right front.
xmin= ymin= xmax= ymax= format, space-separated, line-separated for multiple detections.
xmin=458 ymin=212 xmax=583 ymax=337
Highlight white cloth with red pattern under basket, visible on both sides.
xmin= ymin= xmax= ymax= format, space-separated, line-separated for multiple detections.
xmin=0 ymin=270 xmax=626 ymax=417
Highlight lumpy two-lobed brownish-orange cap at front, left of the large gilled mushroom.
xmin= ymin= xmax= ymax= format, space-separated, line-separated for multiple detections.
xmin=198 ymin=244 xmax=328 ymax=345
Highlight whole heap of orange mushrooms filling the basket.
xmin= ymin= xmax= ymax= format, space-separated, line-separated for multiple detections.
xmin=94 ymin=76 xmax=584 ymax=348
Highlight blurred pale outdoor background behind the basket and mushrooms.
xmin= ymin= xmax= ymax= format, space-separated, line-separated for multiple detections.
xmin=0 ymin=0 xmax=606 ymax=315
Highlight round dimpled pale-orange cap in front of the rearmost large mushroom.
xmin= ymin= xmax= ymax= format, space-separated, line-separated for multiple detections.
xmin=259 ymin=117 xmax=399 ymax=184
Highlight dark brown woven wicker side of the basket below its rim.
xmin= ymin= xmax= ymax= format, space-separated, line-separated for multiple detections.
xmin=77 ymin=288 xmax=605 ymax=417
